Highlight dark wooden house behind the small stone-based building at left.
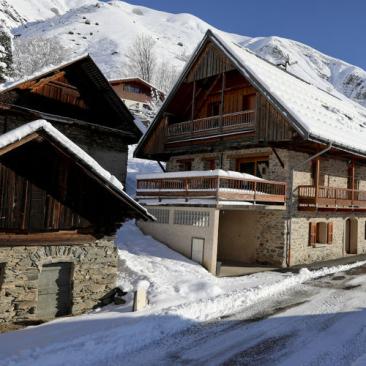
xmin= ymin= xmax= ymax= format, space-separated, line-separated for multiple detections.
xmin=0 ymin=56 xmax=141 ymax=183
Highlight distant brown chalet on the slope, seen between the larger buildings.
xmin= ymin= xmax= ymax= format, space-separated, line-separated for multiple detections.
xmin=110 ymin=77 xmax=164 ymax=127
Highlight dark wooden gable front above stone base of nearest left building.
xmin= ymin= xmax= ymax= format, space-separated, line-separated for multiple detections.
xmin=0 ymin=127 xmax=149 ymax=243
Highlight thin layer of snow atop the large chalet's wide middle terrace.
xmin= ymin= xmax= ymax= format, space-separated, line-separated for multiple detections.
xmin=136 ymin=169 xmax=263 ymax=180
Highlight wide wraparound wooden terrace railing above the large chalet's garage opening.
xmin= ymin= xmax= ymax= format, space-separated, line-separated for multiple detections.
xmin=136 ymin=170 xmax=286 ymax=205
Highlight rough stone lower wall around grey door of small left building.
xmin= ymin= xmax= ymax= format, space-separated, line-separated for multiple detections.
xmin=0 ymin=240 xmax=117 ymax=323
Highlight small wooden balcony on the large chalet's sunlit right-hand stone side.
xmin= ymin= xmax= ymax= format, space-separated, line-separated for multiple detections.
xmin=298 ymin=186 xmax=366 ymax=211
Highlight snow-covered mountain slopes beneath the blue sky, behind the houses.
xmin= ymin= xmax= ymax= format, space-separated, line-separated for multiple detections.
xmin=0 ymin=0 xmax=366 ymax=106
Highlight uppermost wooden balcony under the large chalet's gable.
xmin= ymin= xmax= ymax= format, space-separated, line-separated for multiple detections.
xmin=167 ymin=110 xmax=255 ymax=142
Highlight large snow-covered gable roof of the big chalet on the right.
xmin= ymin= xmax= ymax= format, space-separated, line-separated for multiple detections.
xmin=135 ymin=30 xmax=366 ymax=156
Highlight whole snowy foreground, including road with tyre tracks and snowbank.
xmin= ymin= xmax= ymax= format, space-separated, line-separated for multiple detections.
xmin=0 ymin=222 xmax=366 ymax=366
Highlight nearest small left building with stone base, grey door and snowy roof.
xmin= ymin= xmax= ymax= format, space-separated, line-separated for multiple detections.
xmin=0 ymin=120 xmax=152 ymax=323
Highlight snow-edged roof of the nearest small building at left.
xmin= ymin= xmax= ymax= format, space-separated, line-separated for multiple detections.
xmin=0 ymin=120 xmax=155 ymax=220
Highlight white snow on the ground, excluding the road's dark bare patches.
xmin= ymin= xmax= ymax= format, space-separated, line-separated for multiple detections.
xmin=0 ymin=222 xmax=366 ymax=366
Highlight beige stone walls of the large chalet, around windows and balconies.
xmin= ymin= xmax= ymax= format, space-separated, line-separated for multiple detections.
xmin=167 ymin=148 xmax=366 ymax=266
